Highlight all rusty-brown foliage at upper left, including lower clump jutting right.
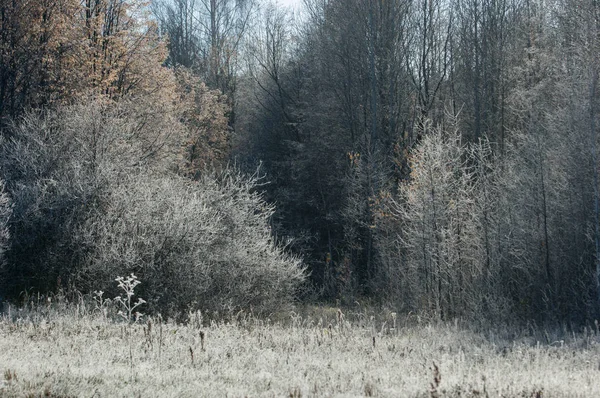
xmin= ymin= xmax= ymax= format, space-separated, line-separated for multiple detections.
xmin=0 ymin=0 xmax=230 ymax=176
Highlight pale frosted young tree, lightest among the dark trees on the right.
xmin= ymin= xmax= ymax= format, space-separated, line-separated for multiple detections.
xmin=385 ymin=122 xmax=500 ymax=319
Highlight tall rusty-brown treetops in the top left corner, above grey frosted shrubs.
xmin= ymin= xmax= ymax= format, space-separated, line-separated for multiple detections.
xmin=0 ymin=0 xmax=174 ymax=117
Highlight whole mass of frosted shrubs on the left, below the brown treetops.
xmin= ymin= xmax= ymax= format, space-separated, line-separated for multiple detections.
xmin=0 ymin=101 xmax=303 ymax=312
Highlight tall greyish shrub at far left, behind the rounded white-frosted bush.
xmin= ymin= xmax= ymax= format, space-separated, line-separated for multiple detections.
xmin=0 ymin=100 xmax=182 ymax=295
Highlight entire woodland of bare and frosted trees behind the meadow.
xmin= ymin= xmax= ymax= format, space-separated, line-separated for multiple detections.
xmin=0 ymin=0 xmax=600 ymax=323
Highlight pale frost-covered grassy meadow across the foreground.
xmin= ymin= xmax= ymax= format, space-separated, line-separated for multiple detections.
xmin=0 ymin=308 xmax=600 ymax=397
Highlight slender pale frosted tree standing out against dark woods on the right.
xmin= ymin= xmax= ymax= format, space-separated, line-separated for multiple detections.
xmin=393 ymin=122 xmax=484 ymax=319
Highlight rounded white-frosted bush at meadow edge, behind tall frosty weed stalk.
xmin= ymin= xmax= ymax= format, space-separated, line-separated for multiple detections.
xmin=76 ymin=171 xmax=303 ymax=312
